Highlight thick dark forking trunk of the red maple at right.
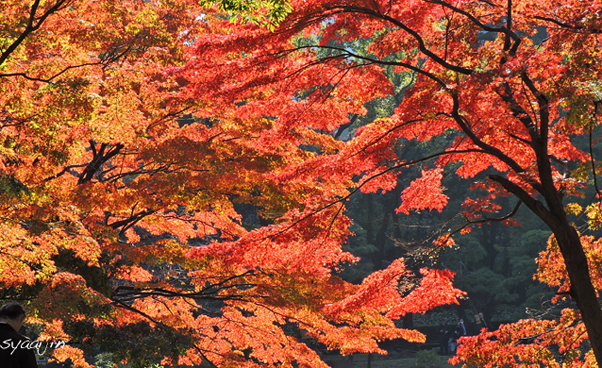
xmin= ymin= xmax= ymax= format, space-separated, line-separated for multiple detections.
xmin=480 ymin=62 xmax=602 ymax=365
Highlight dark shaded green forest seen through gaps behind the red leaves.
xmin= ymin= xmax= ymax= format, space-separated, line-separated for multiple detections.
xmin=297 ymin=27 xmax=602 ymax=333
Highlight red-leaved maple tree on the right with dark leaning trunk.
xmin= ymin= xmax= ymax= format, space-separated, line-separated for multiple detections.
xmin=180 ymin=0 xmax=602 ymax=366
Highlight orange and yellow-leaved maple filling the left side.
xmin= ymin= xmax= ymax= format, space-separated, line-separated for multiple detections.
xmin=0 ymin=0 xmax=462 ymax=367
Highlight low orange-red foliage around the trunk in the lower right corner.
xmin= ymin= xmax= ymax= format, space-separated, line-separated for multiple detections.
xmin=452 ymin=231 xmax=600 ymax=367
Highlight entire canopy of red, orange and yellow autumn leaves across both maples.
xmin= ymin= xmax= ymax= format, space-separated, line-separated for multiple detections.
xmin=0 ymin=0 xmax=602 ymax=367
